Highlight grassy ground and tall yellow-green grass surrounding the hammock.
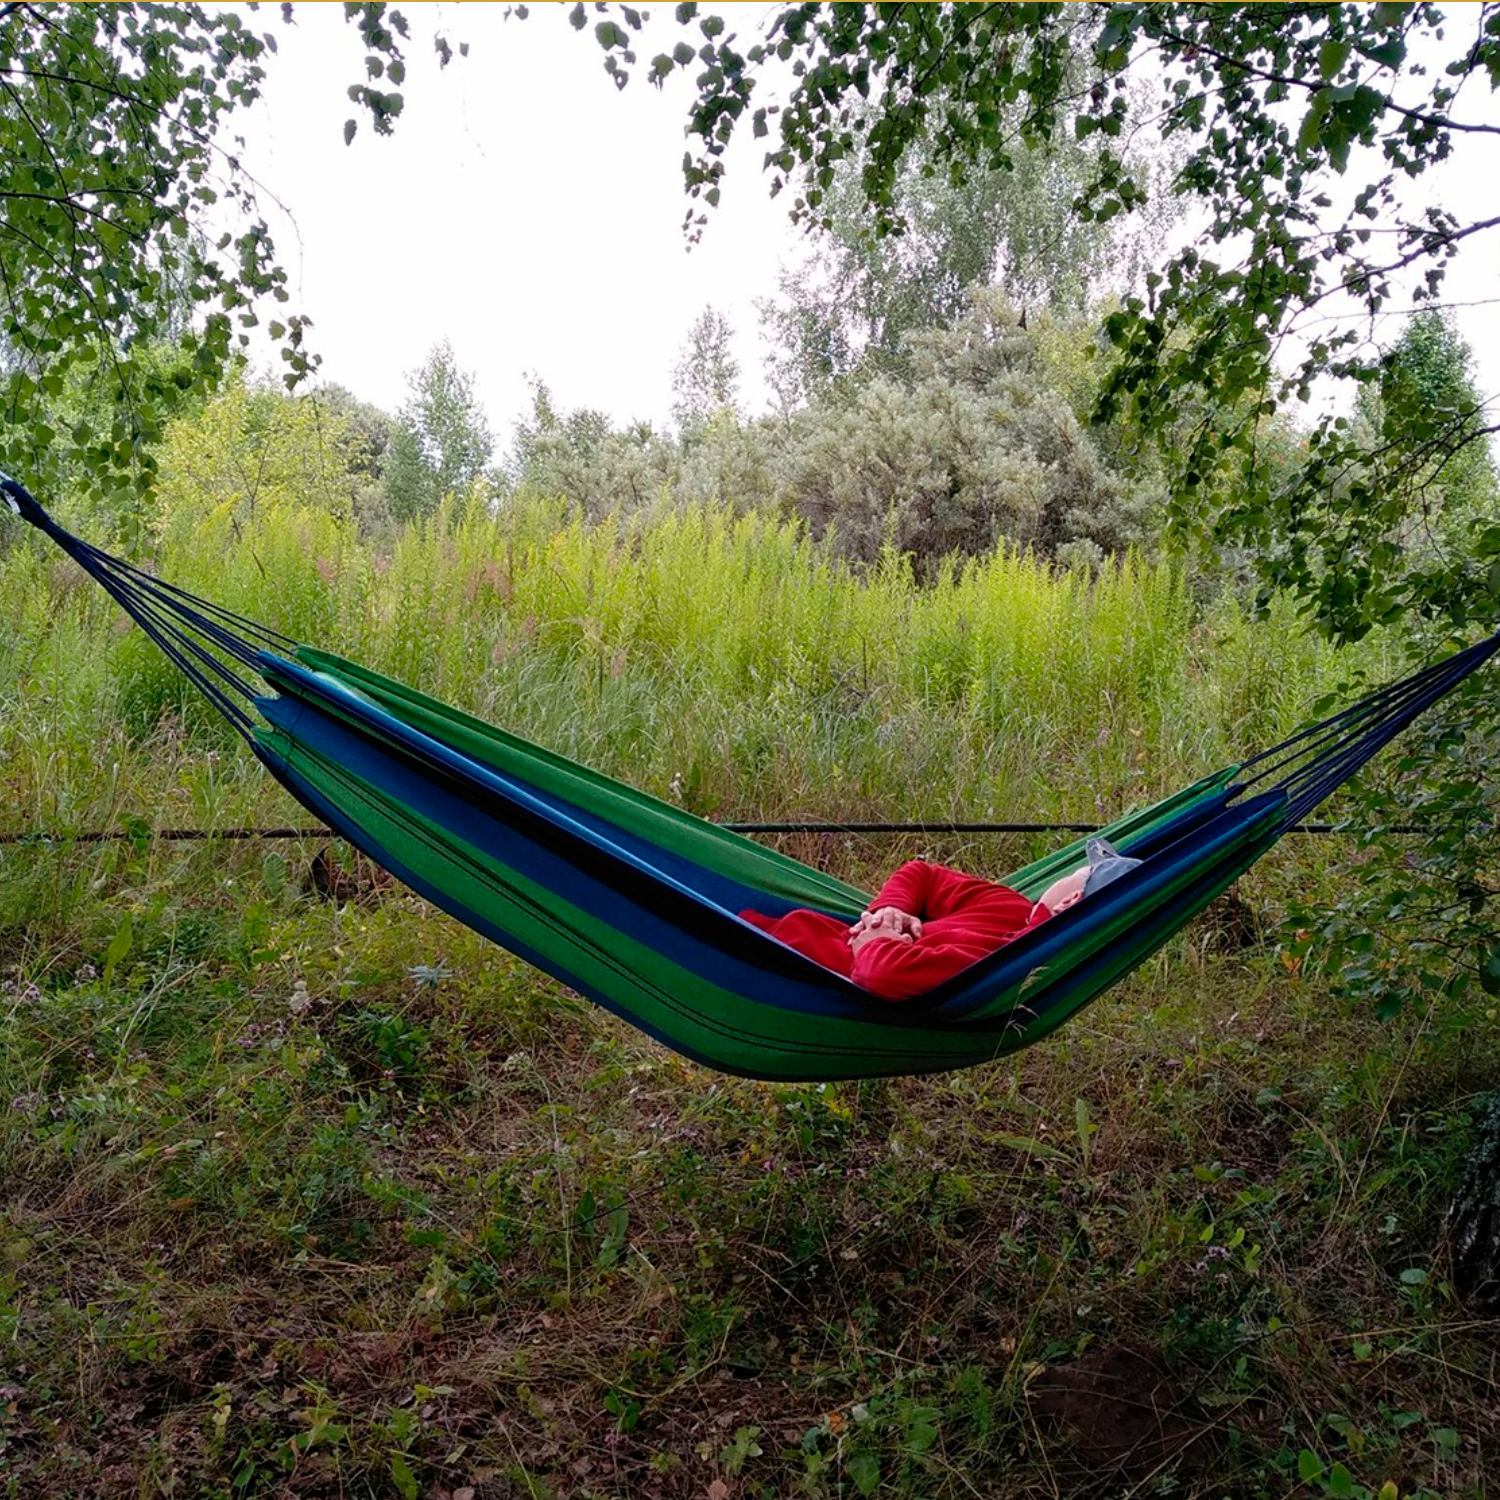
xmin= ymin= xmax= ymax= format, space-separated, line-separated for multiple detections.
xmin=0 ymin=503 xmax=1500 ymax=1500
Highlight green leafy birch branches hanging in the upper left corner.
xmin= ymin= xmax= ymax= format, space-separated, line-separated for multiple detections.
xmin=0 ymin=0 xmax=446 ymax=510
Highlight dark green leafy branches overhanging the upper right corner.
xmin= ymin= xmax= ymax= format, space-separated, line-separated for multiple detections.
xmin=575 ymin=0 xmax=1500 ymax=638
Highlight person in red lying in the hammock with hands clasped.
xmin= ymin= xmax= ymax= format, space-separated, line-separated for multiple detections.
xmin=740 ymin=839 xmax=1140 ymax=1001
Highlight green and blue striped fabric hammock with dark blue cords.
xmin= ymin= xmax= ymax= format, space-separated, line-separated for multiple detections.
xmin=11 ymin=476 xmax=1500 ymax=1082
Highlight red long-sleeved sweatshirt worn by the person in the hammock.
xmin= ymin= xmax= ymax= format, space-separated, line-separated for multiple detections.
xmin=740 ymin=860 xmax=1052 ymax=1001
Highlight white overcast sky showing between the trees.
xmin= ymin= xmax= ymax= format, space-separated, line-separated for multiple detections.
xmin=239 ymin=3 xmax=1500 ymax=449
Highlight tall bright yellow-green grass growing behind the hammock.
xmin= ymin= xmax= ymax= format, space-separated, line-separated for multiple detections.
xmin=0 ymin=497 xmax=1380 ymax=828
